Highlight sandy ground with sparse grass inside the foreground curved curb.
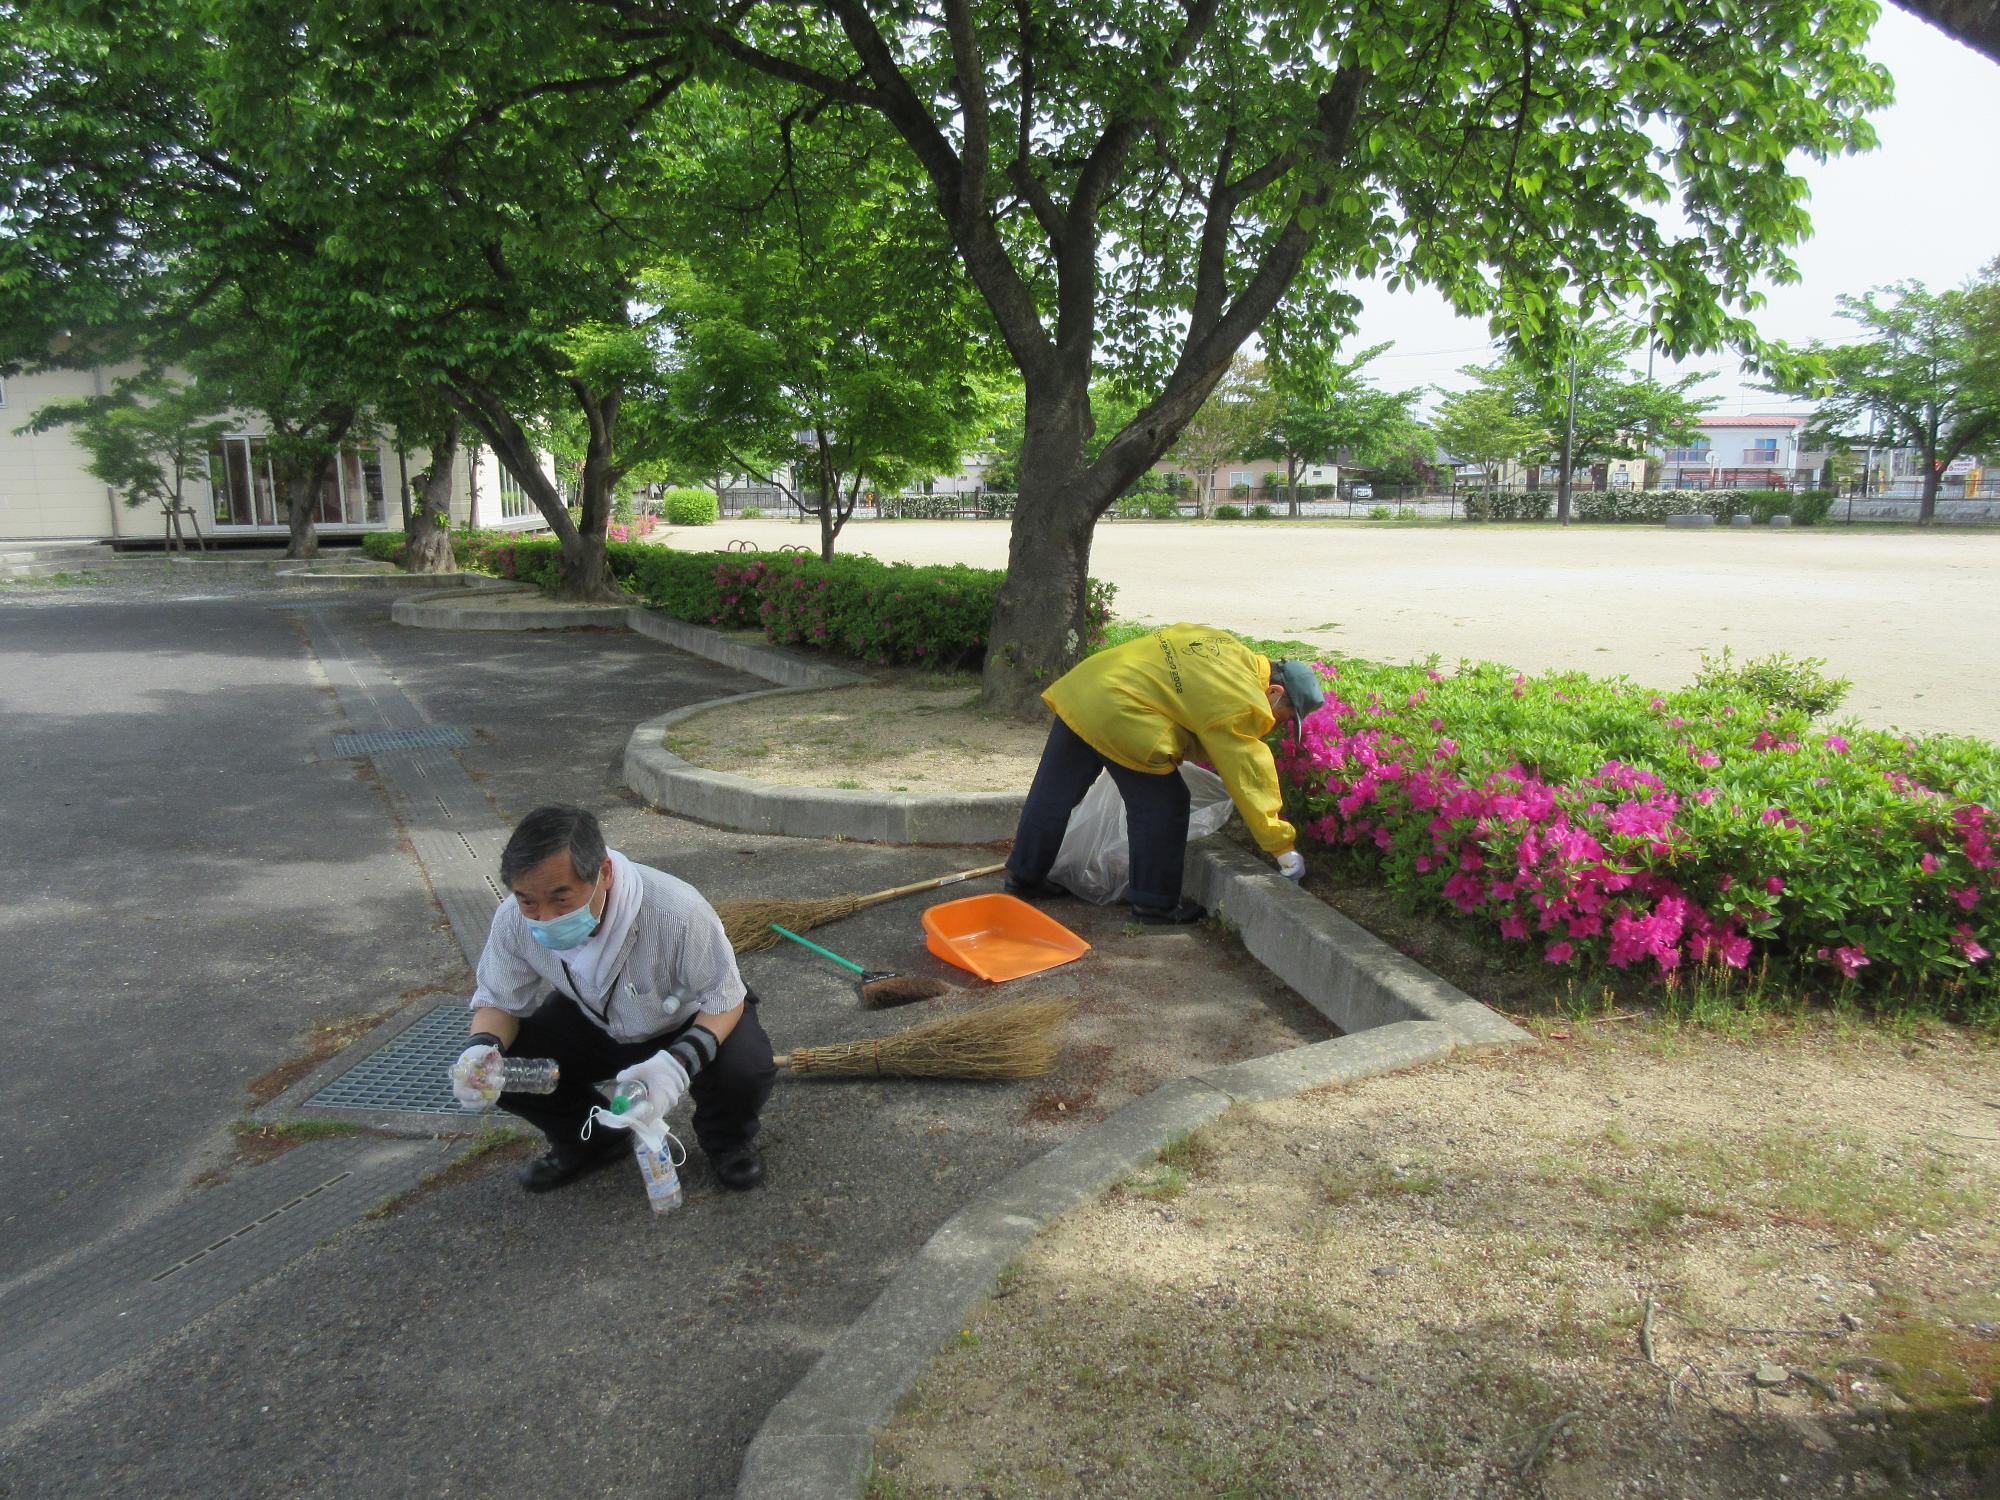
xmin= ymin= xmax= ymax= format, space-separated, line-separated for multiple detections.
xmin=870 ymin=1024 xmax=2000 ymax=1500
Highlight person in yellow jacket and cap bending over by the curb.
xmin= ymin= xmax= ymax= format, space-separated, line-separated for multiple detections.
xmin=1006 ymin=624 xmax=1326 ymax=924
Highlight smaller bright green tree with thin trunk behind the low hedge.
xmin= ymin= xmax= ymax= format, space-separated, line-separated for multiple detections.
xmin=640 ymin=95 xmax=996 ymax=558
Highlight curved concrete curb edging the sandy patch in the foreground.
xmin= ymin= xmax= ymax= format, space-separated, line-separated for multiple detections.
xmin=736 ymin=1016 xmax=1462 ymax=1500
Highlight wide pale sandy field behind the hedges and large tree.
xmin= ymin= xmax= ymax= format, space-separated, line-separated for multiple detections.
xmin=664 ymin=520 xmax=2000 ymax=738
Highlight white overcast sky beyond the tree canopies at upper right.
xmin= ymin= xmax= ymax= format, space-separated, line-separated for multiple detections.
xmin=1348 ymin=4 xmax=2000 ymax=414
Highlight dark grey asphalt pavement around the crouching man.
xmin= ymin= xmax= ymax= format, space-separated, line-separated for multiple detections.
xmin=0 ymin=580 xmax=1330 ymax=1496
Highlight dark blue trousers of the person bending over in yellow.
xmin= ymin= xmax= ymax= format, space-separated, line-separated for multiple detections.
xmin=1006 ymin=718 xmax=1190 ymax=910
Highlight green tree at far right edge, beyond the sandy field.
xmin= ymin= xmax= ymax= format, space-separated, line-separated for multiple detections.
xmin=1780 ymin=280 xmax=2000 ymax=526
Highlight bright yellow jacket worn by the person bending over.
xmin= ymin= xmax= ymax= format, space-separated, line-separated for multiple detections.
xmin=1042 ymin=624 xmax=1296 ymax=854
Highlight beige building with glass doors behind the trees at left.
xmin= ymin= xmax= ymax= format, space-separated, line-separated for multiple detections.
xmin=0 ymin=370 xmax=546 ymax=546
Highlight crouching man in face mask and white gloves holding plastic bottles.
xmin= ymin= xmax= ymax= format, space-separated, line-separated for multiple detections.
xmin=452 ymin=808 xmax=778 ymax=1192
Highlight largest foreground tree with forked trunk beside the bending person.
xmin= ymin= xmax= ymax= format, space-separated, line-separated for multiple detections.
xmin=556 ymin=0 xmax=1888 ymax=712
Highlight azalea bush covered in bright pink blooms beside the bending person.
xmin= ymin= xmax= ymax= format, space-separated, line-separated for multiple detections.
xmin=1278 ymin=662 xmax=2000 ymax=1020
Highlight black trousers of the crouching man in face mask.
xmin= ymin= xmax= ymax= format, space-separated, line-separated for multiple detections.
xmin=500 ymin=994 xmax=778 ymax=1158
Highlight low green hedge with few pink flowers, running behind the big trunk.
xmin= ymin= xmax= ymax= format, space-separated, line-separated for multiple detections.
xmin=376 ymin=532 xmax=1114 ymax=670
